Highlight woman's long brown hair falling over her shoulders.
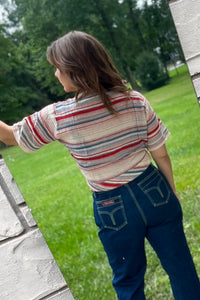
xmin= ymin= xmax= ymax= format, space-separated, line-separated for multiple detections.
xmin=47 ymin=31 xmax=129 ymax=113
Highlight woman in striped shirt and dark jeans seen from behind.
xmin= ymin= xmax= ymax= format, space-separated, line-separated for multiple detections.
xmin=0 ymin=31 xmax=200 ymax=300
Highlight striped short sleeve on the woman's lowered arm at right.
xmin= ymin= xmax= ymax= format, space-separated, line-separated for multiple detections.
xmin=145 ymin=99 xmax=170 ymax=151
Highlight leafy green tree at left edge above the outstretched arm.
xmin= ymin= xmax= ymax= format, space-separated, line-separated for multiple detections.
xmin=0 ymin=25 xmax=47 ymax=124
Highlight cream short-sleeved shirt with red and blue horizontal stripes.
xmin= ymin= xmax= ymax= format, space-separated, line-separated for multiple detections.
xmin=13 ymin=91 xmax=169 ymax=191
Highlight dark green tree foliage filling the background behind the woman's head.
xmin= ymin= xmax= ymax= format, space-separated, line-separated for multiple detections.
xmin=0 ymin=0 xmax=182 ymax=123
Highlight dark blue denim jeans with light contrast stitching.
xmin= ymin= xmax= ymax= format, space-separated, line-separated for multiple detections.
xmin=93 ymin=165 xmax=200 ymax=300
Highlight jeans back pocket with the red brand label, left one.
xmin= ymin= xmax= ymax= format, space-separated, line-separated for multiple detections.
xmin=95 ymin=195 xmax=128 ymax=231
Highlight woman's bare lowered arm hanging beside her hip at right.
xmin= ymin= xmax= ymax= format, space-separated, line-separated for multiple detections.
xmin=150 ymin=145 xmax=178 ymax=198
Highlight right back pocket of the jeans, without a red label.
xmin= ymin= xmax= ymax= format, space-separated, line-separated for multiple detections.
xmin=138 ymin=170 xmax=171 ymax=207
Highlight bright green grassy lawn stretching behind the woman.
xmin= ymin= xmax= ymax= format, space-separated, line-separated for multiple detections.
xmin=2 ymin=67 xmax=200 ymax=300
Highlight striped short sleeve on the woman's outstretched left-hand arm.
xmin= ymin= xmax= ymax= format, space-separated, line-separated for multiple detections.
xmin=13 ymin=104 xmax=56 ymax=152
